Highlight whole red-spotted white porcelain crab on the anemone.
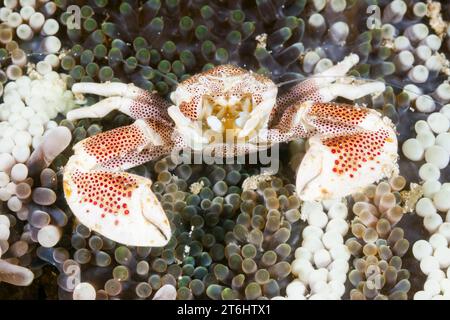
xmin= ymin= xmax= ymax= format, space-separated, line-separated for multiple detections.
xmin=64 ymin=54 xmax=397 ymax=246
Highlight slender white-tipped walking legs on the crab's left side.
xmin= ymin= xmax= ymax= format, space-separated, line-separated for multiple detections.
xmin=67 ymin=82 xmax=170 ymax=121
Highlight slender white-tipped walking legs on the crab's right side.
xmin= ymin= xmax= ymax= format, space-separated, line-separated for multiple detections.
xmin=271 ymin=54 xmax=385 ymax=125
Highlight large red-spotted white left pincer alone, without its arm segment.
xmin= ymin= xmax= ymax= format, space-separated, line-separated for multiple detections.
xmin=64 ymin=171 xmax=171 ymax=247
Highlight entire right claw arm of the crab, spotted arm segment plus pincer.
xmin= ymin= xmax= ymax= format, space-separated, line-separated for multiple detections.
xmin=268 ymin=102 xmax=397 ymax=200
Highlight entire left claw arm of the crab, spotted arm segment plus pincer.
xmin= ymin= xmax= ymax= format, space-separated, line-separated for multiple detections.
xmin=64 ymin=119 xmax=183 ymax=246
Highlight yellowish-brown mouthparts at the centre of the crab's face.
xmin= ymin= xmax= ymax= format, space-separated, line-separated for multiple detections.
xmin=200 ymin=94 xmax=254 ymax=140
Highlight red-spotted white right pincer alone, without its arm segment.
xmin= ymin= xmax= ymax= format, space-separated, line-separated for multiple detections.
xmin=296 ymin=130 xmax=397 ymax=201
